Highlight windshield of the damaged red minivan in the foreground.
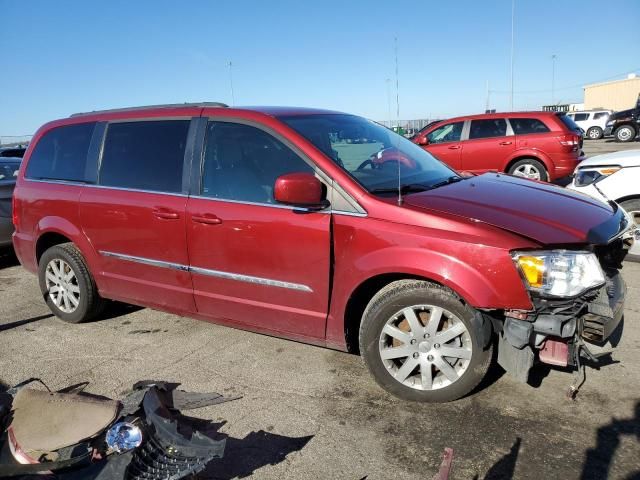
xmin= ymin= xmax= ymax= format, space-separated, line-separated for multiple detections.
xmin=279 ymin=114 xmax=459 ymax=194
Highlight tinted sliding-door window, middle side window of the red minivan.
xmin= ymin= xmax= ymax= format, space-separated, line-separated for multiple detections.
xmin=99 ymin=120 xmax=190 ymax=193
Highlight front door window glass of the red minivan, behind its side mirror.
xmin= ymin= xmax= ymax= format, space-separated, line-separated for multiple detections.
xmin=201 ymin=122 xmax=313 ymax=203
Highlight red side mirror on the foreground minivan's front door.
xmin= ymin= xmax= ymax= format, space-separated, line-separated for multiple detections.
xmin=273 ymin=173 xmax=329 ymax=210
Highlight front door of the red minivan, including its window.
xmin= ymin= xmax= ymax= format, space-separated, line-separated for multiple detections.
xmin=187 ymin=121 xmax=331 ymax=339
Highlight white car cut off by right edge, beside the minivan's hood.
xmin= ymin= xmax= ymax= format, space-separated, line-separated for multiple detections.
xmin=567 ymin=150 xmax=640 ymax=261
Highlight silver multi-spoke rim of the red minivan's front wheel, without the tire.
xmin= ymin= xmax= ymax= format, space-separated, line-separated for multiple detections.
xmin=378 ymin=305 xmax=473 ymax=390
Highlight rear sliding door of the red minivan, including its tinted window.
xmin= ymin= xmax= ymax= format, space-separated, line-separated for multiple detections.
xmin=80 ymin=119 xmax=195 ymax=311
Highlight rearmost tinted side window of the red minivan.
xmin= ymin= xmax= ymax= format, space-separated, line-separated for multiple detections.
xmin=25 ymin=123 xmax=95 ymax=182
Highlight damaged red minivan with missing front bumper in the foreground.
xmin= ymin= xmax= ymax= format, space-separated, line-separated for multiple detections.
xmin=13 ymin=104 xmax=633 ymax=401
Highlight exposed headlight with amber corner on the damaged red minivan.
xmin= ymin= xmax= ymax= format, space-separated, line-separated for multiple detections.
xmin=512 ymin=250 xmax=605 ymax=297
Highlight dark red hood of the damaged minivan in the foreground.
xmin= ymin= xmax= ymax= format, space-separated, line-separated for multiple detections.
xmin=404 ymin=173 xmax=626 ymax=245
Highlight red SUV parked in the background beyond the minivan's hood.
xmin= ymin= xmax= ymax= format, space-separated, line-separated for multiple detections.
xmin=411 ymin=112 xmax=582 ymax=182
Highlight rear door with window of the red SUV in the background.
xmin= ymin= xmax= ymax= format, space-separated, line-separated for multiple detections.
xmin=462 ymin=118 xmax=516 ymax=173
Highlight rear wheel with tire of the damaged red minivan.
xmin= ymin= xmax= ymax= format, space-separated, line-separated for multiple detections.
xmin=38 ymin=243 xmax=104 ymax=323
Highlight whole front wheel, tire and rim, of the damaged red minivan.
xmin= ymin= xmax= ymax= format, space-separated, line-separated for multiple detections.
xmin=360 ymin=280 xmax=493 ymax=402
